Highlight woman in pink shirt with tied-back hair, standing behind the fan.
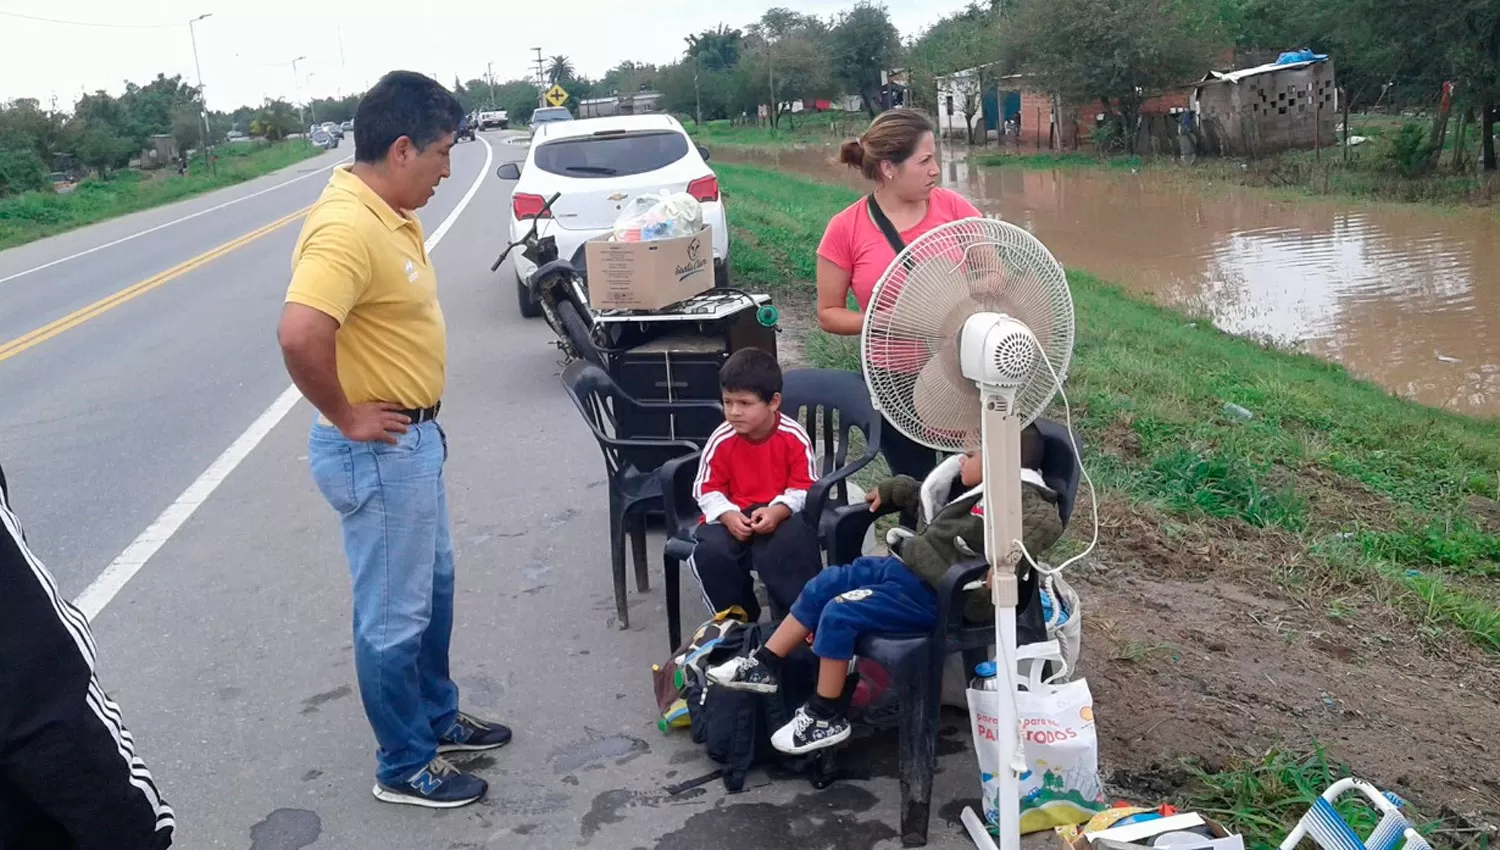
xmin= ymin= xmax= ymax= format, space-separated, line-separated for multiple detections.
xmin=818 ymin=109 xmax=980 ymax=481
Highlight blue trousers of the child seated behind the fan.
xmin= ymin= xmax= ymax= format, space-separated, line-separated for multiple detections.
xmin=792 ymin=558 xmax=938 ymax=661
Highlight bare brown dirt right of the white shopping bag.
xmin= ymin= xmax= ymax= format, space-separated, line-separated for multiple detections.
xmin=1074 ymin=502 xmax=1500 ymax=823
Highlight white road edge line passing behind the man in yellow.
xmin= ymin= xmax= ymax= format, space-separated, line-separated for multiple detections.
xmin=74 ymin=136 xmax=495 ymax=621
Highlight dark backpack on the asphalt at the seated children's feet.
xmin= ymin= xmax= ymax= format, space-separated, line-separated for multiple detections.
xmin=683 ymin=624 xmax=855 ymax=793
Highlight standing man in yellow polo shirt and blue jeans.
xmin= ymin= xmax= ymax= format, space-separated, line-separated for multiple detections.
xmin=278 ymin=70 xmax=510 ymax=808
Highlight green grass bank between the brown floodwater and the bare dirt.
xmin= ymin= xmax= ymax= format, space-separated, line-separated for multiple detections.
xmin=719 ymin=165 xmax=1500 ymax=652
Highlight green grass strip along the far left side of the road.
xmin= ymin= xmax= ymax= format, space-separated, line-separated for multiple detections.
xmin=0 ymin=139 xmax=321 ymax=250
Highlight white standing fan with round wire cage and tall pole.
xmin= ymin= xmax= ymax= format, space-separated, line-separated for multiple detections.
xmin=860 ymin=217 xmax=1073 ymax=850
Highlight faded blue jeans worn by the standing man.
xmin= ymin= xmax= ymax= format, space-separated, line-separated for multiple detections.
xmin=308 ymin=421 xmax=459 ymax=786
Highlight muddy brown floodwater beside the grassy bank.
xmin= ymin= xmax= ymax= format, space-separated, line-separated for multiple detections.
xmin=722 ymin=148 xmax=1500 ymax=415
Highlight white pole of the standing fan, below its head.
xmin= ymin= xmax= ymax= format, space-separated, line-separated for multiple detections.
xmin=971 ymin=391 xmax=1026 ymax=850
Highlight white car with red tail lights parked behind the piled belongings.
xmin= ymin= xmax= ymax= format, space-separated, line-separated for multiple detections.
xmin=500 ymin=115 xmax=729 ymax=318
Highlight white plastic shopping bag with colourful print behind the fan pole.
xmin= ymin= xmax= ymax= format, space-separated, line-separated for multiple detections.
xmin=968 ymin=640 xmax=1106 ymax=835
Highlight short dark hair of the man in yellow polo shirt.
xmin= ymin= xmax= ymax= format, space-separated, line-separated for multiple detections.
xmin=354 ymin=70 xmax=464 ymax=162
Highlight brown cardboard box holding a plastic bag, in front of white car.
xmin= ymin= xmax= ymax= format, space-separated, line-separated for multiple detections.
xmin=584 ymin=226 xmax=714 ymax=310
